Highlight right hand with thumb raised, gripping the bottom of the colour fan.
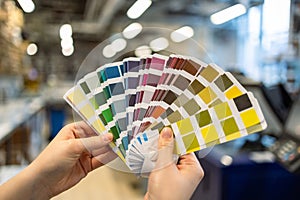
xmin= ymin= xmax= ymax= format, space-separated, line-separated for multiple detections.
xmin=145 ymin=128 xmax=204 ymax=200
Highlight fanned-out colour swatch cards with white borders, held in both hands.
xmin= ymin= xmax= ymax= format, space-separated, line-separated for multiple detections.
xmin=64 ymin=54 xmax=267 ymax=175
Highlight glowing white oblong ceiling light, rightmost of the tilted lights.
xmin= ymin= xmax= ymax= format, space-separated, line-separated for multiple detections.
xmin=210 ymin=4 xmax=246 ymax=25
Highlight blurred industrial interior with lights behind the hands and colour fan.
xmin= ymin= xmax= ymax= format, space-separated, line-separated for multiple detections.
xmin=0 ymin=0 xmax=300 ymax=200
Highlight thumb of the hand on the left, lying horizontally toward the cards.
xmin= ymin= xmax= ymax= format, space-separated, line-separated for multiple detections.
xmin=78 ymin=133 xmax=113 ymax=152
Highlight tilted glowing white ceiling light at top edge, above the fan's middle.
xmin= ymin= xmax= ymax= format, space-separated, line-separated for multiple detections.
xmin=127 ymin=0 xmax=152 ymax=19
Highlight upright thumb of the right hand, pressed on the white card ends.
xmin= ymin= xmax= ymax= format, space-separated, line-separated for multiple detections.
xmin=155 ymin=127 xmax=174 ymax=169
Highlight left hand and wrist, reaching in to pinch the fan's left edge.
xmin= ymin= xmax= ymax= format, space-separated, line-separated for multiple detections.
xmin=0 ymin=122 xmax=116 ymax=199
